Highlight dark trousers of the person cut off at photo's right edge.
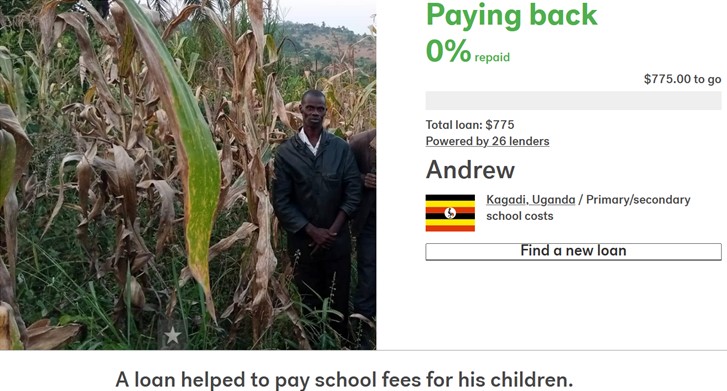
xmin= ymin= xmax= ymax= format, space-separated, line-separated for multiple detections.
xmin=353 ymin=213 xmax=376 ymax=319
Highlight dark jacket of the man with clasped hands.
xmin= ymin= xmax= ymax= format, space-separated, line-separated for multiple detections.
xmin=272 ymin=131 xmax=362 ymax=254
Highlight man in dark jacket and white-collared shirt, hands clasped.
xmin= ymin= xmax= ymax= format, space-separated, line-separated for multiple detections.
xmin=272 ymin=90 xmax=361 ymax=344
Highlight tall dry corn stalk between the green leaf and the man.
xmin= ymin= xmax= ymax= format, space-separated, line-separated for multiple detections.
xmin=164 ymin=0 xmax=309 ymax=348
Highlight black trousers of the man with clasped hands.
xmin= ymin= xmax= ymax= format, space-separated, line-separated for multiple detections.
xmin=294 ymin=243 xmax=351 ymax=339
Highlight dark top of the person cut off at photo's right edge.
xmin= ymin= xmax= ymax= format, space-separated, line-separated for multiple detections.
xmin=349 ymin=129 xmax=376 ymax=235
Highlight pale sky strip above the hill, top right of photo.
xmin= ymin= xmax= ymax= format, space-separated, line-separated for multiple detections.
xmin=278 ymin=0 xmax=376 ymax=34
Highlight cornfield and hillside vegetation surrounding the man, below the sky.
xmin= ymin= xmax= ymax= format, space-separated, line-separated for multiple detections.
xmin=0 ymin=0 xmax=376 ymax=350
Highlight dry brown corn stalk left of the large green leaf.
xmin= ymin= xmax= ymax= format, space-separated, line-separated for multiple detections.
xmin=39 ymin=0 xmax=152 ymax=319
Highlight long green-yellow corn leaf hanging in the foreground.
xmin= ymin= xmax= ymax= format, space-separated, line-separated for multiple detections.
xmin=112 ymin=0 xmax=221 ymax=319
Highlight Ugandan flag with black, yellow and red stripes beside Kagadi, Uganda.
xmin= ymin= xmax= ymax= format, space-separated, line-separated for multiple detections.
xmin=426 ymin=194 xmax=475 ymax=232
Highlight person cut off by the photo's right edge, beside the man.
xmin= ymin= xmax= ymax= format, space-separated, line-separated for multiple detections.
xmin=350 ymin=129 xmax=376 ymax=349
